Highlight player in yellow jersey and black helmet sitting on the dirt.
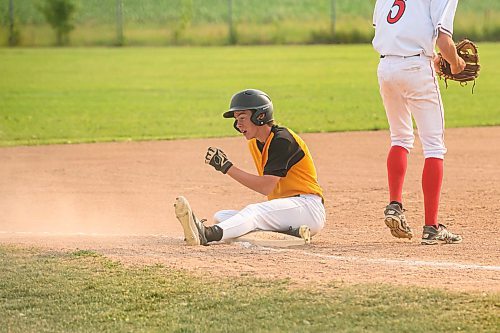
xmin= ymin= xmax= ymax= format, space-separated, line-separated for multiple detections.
xmin=175 ymin=89 xmax=326 ymax=245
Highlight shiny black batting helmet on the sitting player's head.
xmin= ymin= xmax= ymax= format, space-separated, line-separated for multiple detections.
xmin=223 ymin=89 xmax=273 ymax=126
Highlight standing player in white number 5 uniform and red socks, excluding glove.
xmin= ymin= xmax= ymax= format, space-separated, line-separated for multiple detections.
xmin=373 ymin=0 xmax=465 ymax=245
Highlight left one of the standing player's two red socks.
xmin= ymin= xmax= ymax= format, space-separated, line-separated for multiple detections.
xmin=387 ymin=146 xmax=408 ymax=203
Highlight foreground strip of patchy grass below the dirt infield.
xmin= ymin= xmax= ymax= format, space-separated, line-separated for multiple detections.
xmin=0 ymin=246 xmax=500 ymax=333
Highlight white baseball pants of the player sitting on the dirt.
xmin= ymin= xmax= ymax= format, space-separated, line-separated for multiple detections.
xmin=214 ymin=194 xmax=326 ymax=240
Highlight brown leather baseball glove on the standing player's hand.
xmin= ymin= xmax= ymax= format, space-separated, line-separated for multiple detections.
xmin=438 ymin=39 xmax=481 ymax=89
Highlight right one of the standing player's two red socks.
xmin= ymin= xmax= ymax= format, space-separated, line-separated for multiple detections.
xmin=422 ymin=157 xmax=443 ymax=227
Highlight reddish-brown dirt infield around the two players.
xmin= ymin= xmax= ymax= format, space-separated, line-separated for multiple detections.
xmin=0 ymin=127 xmax=500 ymax=292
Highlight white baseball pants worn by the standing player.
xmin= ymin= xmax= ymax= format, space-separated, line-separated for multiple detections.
xmin=377 ymin=55 xmax=446 ymax=159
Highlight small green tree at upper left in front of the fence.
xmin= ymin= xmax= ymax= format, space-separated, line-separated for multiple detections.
xmin=38 ymin=0 xmax=76 ymax=46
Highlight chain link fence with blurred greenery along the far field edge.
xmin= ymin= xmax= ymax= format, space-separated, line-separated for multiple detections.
xmin=0 ymin=0 xmax=500 ymax=46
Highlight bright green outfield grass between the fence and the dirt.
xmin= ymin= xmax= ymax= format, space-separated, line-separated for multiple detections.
xmin=0 ymin=43 xmax=500 ymax=146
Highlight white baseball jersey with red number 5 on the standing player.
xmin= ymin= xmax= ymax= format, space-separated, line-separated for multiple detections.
xmin=372 ymin=0 xmax=458 ymax=57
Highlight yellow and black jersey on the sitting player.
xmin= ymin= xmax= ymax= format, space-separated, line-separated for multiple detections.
xmin=248 ymin=125 xmax=323 ymax=200
